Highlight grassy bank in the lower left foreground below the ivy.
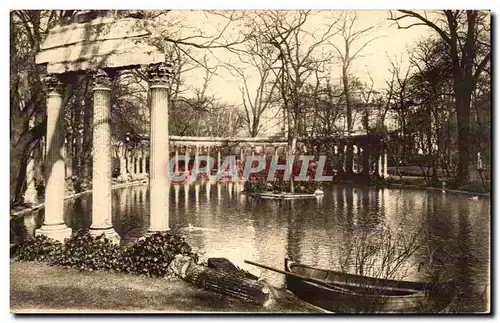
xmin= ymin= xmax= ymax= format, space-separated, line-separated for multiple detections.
xmin=10 ymin=260 xmax=313 ymax=313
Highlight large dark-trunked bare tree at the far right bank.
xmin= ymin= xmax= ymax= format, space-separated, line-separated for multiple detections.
xmin=389 ymin=10 xmax=491 ymax=183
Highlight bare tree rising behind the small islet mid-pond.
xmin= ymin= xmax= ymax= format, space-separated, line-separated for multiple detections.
xmin=242 ymin=10 xmax=338 ymax=192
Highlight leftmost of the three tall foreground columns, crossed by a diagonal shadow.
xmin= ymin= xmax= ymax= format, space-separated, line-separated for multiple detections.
xmin=35 ymin=76 xmax=71 ymax=242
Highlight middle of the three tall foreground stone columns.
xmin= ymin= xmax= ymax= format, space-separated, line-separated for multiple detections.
xmin=90 ymin=70 xmax=120 ymax=243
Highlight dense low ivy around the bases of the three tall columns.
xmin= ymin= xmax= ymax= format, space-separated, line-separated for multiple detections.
xmin=11 ymin=230 xmax=198 ymax=277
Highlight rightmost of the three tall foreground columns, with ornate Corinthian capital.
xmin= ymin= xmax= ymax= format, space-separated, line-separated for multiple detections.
xmin=148 ymin=63 xmax=172 ymax=233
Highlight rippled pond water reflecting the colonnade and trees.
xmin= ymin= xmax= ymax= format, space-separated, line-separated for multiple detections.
xmin=11 ymin=183 xmax=491 ymax=312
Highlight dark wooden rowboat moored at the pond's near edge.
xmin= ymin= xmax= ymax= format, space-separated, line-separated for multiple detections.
xmin=285 ymin=259 xmax=455 ymax=313
